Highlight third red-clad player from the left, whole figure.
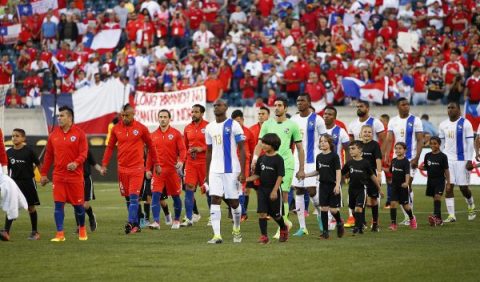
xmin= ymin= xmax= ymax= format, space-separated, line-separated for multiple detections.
xmin=146 ymin=109 xmax=187 ymax=229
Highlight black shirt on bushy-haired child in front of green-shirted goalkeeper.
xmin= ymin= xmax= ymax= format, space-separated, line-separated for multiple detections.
xmin=255 ymin=154 xmax=285 ymax=189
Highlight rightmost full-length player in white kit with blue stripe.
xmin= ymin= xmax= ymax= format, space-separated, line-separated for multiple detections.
xmin=438 ymin=102 xmax=477 ymax=222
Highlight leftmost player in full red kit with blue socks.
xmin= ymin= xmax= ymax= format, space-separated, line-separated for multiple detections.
xmin=40 ymin=106 xmax=88 ymax=242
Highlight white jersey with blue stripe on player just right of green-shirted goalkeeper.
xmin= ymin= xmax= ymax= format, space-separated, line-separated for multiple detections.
xmin=291 ymin=113 xmax=327 ymax=169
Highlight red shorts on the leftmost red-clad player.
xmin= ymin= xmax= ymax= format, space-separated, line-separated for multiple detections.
xmin=52 ymin=178 xmax=85 ymax=205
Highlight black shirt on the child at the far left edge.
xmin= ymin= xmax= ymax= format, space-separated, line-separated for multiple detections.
xmin=7 ymin=146 xmax=40 ymax=180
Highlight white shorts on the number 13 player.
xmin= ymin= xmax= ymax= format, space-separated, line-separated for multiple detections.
xmin=208 ymin=172 xmax=242 ymax=199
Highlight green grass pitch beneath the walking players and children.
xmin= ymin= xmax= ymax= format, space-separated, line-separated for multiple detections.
xmin=0 ymin=183 xmax=480 ymax=281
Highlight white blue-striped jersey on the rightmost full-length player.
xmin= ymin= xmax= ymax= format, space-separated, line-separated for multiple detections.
xmin=438 ymin=117 xmax=474 ymax=161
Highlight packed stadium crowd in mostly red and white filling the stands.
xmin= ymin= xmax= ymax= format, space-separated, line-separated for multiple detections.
xmin=0 ymin=0 xmax=480 ymax=107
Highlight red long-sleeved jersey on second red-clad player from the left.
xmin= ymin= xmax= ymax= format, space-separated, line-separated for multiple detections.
xmin=102 ymin=121 xmax=159 ymax=173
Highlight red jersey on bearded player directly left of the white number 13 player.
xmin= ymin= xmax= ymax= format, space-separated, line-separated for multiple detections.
xmin=183 ymin=119 xmax=208 ymax=162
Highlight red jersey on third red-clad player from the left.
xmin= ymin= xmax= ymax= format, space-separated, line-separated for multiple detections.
xmin=147 ymin=126 xmax=187 ymax=170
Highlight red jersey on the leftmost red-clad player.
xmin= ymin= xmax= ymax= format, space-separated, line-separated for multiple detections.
xmin=40 ymin=125 xmax=88 ymax=181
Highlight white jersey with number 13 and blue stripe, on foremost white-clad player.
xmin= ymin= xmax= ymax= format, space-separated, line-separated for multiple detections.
xmin=205 ymin=118 xmax=245 ymax=173
